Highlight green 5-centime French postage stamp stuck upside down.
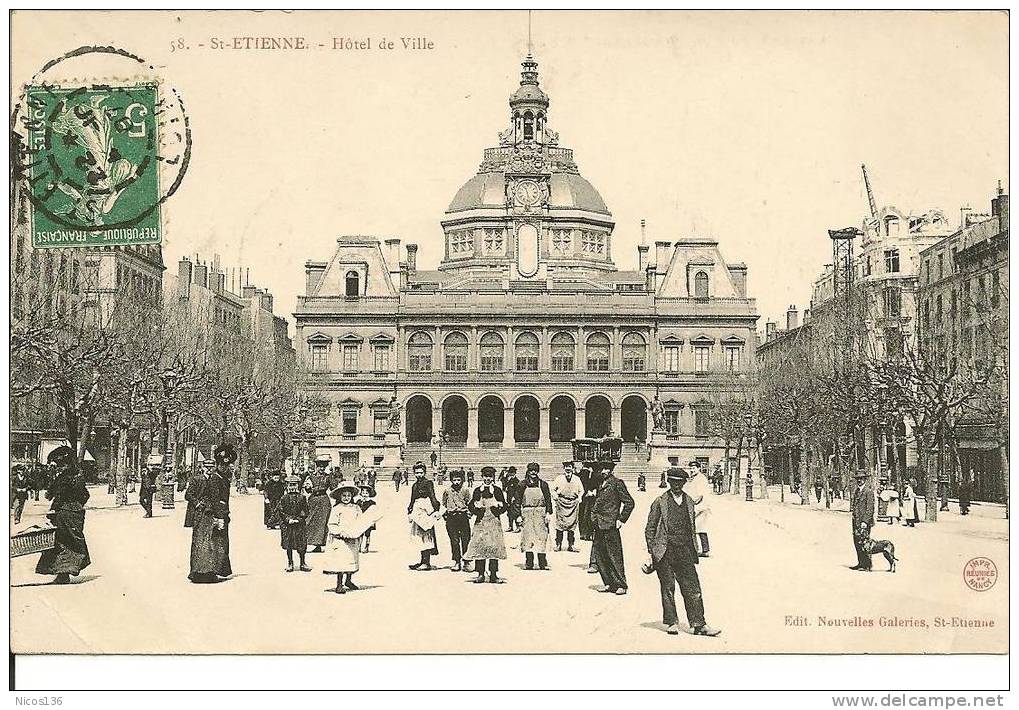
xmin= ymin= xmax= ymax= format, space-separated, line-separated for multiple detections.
xmin=25 ymin=83 xmax=161 ymax=248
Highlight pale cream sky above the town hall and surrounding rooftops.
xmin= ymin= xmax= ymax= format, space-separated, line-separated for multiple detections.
xmin=11 ymin=11 xmax=1009 ymax=327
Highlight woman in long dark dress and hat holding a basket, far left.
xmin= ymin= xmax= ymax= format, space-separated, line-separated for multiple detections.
xmin=36 ymin=446 xmax=92 ymax=585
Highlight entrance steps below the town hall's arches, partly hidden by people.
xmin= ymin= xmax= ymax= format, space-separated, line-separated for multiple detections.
xmin=404 ymin=442 xmax=652 ymax=485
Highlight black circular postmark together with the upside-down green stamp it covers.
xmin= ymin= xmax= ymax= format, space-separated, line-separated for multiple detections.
xmin=11 ymin=46 xmax=192 ymax=247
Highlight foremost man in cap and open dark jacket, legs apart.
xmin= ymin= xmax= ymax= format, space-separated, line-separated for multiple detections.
xmin=644 ymin=467 xmax=721 ymax=636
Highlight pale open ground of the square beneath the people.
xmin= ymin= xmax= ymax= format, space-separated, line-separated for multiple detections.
xmin=11 ymin=483 xmax=1009 ymax=653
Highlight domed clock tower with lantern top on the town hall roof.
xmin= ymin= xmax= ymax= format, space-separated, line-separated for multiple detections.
xmin=439 ymin=54 xmax=615 ymax=281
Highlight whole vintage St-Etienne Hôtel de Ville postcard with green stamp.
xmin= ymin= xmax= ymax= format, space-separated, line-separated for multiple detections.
xmin=9 ymin=10 xmax=1010 ymax=655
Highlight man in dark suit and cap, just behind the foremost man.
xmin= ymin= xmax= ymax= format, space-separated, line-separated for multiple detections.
xmin=591 ymin=461 xmax=634 ymax=594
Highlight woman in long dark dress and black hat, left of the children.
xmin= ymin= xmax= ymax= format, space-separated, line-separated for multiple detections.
xmin=187 ymin=444 xmax=237 ymax=584
